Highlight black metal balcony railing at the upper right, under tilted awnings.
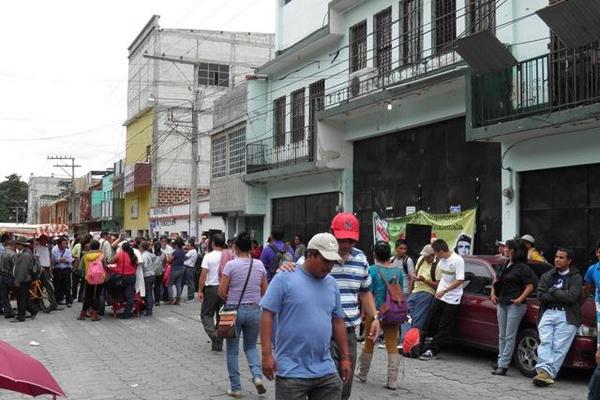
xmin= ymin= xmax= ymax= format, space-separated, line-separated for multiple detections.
xmin=471 ymin=49 xmax=600 ymax=127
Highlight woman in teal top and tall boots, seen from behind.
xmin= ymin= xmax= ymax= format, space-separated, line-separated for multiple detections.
xmin=356 ymin=241 xmax=404 ymax=390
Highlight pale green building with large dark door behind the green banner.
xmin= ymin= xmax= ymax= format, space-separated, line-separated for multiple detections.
xmin=244 ymin=0 xmax=512 ymax=253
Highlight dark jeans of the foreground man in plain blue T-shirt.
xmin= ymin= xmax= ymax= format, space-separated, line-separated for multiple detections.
xmin=275 ymin=374 xmax=342 ymax=400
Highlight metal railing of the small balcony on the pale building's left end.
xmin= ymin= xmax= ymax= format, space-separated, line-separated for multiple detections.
xmin=246 ymin=127 xmax=316 ymax=174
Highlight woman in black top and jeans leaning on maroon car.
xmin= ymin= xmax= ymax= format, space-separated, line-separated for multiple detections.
xmin=490 ymin=239 xmax=537 ymax=376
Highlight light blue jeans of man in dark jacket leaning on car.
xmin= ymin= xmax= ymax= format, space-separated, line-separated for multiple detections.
xmin=535 ymin=310 xmax=577 ymax=379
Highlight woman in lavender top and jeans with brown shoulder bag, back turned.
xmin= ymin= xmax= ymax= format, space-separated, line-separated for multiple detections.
xmin=218 ymin=233 xmax=267 ymax=397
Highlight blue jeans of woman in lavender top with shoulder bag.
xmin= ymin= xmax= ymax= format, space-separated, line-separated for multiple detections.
xmin=225 ymin=304 xmax=262 ymax=390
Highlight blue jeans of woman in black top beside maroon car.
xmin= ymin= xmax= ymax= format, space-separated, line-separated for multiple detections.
xmin=496 ymin=303 xmax=527 ymax=368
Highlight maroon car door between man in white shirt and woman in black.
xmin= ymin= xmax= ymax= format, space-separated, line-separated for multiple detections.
xmin=457 ymin=260 xmax=498 ymax=347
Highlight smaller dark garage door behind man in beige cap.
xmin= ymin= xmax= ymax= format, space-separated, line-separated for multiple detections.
xmin=272 ymin=192 xmax=340 ymax=243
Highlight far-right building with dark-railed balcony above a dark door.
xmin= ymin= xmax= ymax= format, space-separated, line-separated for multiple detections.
xmin=466 ymin=0 xmax=600 ymax=266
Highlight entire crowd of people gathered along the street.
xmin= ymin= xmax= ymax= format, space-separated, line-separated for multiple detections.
xmin=0 ymin=213 xmax=600 ymax=400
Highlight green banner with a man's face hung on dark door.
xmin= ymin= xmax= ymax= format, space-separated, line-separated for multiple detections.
xmin=373 ymin=209 xmax=477 ymax=255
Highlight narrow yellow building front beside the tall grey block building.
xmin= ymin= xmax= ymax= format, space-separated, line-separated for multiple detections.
xmin=123 ymin=108 xmax=154 ymax=237
